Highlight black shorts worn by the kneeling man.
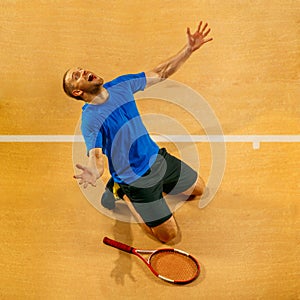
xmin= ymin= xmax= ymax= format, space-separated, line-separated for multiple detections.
xmin=120 ymin=148 xmax=198 ymax=227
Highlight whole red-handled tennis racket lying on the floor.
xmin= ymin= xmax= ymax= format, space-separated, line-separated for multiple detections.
xmin=103 ymin=237 xmax=200 ymax=284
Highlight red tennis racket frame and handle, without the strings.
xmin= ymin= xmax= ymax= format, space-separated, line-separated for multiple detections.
xmin=103 ymin=237 xmax=200 ymax=284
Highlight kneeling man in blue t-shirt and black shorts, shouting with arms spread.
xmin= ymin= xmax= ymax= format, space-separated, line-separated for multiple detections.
xmin=63 ymin=21 xmax=212 ymax=243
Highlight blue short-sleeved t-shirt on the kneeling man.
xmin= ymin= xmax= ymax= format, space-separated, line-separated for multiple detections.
xmin=81 ymin=72 xmax=159 ymax=184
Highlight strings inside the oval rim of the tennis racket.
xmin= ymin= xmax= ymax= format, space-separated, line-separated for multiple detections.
xmin=150 ymin=250 xmax=199 ymax=281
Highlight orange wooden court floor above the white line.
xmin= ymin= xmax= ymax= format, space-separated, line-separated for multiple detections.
xmin=0 ymin=0 xmax=300 ymax=134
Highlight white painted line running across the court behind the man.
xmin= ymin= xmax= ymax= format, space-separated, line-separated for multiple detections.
xmin=0 ymin=135 xmax=300 ymax=149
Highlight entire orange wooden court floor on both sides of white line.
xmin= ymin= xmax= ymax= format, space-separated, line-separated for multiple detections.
xmin=0 ymin=0 xmax=300 ymax=299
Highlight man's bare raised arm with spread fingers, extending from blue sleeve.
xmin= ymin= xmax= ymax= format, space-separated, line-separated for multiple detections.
xmin=146 ymin=21 xmax=212 ymax=87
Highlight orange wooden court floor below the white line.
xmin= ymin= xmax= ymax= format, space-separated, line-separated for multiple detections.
xmin=0 ymin=143 xmax=300 ymax=299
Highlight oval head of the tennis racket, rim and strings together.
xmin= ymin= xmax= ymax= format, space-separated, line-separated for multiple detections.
xmin=148 ymin=248 xmax=200 ymax=284
